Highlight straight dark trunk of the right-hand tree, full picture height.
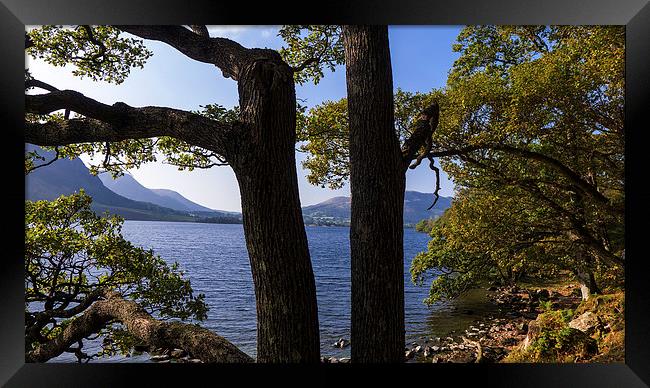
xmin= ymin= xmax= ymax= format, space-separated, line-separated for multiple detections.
xmin=343 ymin=26 xmax=405 ymax=362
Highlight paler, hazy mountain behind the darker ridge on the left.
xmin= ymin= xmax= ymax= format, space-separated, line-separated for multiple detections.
xmin=98 ymin=173 xmax=215 ymax=212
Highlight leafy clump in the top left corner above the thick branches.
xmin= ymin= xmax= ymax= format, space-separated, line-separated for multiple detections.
xmin=27 ymin=25 xmax=152 ymax=84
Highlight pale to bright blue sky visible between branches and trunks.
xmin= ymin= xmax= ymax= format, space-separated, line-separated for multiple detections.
xmin=26 ymin=26 xmax=462 ymax=212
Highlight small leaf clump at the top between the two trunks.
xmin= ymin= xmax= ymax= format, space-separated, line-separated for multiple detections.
xmin=279 ymin=25 xmax=345 ymax=84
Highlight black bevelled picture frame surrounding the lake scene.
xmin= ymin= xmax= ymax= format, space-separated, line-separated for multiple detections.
xmin=0 ymin=0 xmax=650 ymax=387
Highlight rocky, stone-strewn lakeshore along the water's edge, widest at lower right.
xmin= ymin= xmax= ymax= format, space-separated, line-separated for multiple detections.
xmin=149 ymin=278 xmax=623 ymax=364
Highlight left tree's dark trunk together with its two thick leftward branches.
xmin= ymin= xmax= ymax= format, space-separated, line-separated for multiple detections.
xmin=26 ymin=26 xmax=320 ymax=363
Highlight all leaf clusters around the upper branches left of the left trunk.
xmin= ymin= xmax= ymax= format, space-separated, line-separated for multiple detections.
xmin=25 ymin=25 xmax=239 ymax=177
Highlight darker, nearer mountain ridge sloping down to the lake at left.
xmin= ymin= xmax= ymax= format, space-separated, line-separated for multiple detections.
xmin=25 ymin=144 xmax=241 ymax=223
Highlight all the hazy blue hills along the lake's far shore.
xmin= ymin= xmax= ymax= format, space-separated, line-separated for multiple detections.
xmin=25 ymin=145 xmax=452 ymax=226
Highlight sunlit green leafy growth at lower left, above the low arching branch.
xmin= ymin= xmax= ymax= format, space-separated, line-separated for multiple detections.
xmin=25 ymin=191 xmax=208 ymax=360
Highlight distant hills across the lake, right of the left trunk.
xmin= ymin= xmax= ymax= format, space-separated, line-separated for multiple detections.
xmin=302 ymin=191 xmax=453 ymax=225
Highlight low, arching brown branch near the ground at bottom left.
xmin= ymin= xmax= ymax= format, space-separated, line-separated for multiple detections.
xmin=25 ymin=292 xmax=253 ymax=363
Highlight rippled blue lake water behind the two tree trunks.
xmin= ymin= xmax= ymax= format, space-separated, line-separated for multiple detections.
xmin=53 ymin=221 xmax=490 ymax=362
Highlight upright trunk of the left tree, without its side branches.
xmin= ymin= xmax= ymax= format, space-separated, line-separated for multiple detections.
xmin=232 ymin=57 xmax=320 ymax=363
